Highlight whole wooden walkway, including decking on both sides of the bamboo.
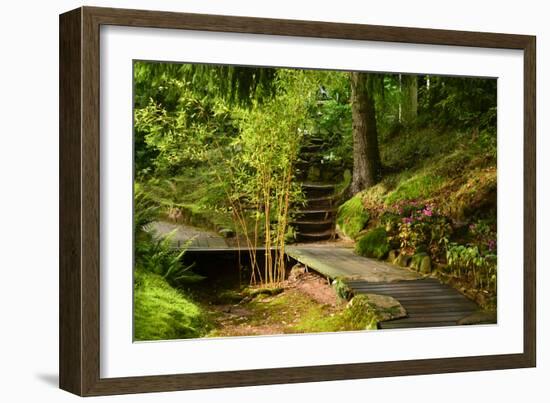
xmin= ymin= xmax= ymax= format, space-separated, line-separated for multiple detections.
xmin=148 ymin=223 xmax=495 ymax=329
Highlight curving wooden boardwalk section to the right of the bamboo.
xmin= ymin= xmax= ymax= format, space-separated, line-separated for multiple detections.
xmin=287 ymin=245 xmax=486 ymax=329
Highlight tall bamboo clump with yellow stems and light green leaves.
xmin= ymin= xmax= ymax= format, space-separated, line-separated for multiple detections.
xmin=225 ymin=69 xmax=317 ymax=283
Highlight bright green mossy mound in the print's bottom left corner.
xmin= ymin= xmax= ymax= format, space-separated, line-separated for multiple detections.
xmin=134 ymin=271 xmax=208 ymax=341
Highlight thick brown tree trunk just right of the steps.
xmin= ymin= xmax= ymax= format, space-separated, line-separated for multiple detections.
xmin=350 ymin=72 xmax=381 ymax=195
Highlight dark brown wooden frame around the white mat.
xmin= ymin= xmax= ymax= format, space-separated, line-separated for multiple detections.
xmin=59 ymin=7 xmax=536 ymax=396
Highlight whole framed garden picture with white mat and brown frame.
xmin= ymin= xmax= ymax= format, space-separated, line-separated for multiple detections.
xmin=60 ymin=7 xmax=536 ymax=396
